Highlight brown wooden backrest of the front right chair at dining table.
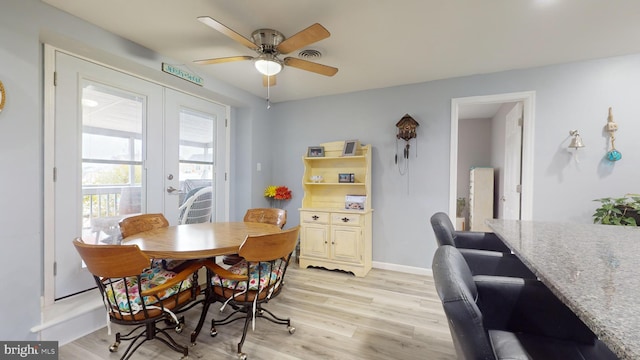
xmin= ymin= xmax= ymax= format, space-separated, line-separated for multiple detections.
xmin=238 ymin=226 xmax=300 ymax=262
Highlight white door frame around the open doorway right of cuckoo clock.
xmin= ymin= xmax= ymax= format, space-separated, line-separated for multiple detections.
xmin=449 ymin=91 xmax=536 ymax=221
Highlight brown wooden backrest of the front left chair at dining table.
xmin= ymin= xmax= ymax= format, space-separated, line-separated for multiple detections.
xmin=73 ymin=238 xmax=150 ymax=278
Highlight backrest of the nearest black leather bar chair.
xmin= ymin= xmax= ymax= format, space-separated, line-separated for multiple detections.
xmin=432 ymin=245 xmax=495 ymax=360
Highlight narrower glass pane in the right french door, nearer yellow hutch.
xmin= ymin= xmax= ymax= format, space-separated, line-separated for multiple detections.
xmin=178 ymin=108 xmax=216 ymax=223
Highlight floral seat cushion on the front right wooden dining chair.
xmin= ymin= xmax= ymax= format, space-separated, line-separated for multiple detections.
xmin=211 ymin=260 xmax=284 ymax=291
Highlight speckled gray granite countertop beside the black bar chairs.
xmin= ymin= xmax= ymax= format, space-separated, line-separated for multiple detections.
xmin=487 ymin=219 xmax=640 ymax=359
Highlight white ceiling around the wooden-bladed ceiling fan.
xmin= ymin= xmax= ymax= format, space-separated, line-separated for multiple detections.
xmin=42 ymin=0 xmax=640 ymax=102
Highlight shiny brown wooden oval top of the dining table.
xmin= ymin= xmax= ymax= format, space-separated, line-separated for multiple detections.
xmin=122 ymin=222 xmax=281 ymax=260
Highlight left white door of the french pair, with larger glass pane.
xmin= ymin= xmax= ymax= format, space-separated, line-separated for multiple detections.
xmin=54 ymin=52 xmax=164 ymax=299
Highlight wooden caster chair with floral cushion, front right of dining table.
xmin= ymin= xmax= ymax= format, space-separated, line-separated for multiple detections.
xmin=191 ymin=226 xmax=300 ymax=359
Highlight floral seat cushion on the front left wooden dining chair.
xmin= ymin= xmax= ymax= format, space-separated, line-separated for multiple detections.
xmin=105 ymin=267 xmax=193 ymax=314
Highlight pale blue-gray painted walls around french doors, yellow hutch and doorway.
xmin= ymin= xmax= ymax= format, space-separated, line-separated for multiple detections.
xmin=0 ymin=0 xmax=640 ymax=340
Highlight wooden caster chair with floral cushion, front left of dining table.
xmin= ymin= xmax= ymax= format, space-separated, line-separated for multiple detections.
xmin=73 ymin=238 xmax=203 ymax=359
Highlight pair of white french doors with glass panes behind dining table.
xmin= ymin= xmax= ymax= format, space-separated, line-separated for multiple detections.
xmin=53 ymin=51 xmax=226 ymax=299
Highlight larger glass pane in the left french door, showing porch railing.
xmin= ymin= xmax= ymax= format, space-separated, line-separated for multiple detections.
xmin=82 ymin=80 xmax=145 ymax=243
